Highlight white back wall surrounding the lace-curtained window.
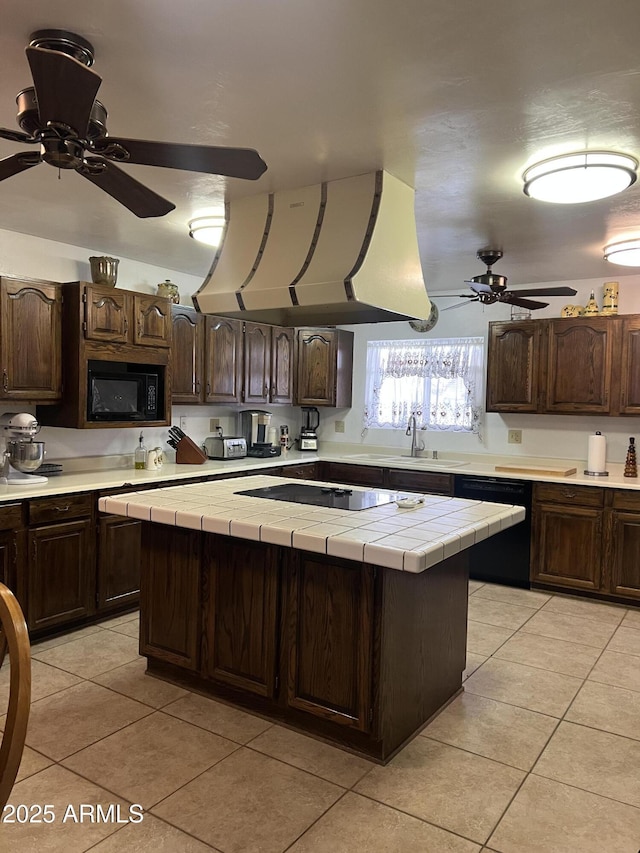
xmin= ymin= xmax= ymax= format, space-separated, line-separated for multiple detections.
xmin=319 ymin=274 xmax=640 ymax=462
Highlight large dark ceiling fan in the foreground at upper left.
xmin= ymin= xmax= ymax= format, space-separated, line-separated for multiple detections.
xmin=0 ymin=30 xmax=267 ymax=217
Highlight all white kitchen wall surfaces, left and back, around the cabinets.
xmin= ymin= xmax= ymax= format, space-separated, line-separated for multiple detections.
xmin=0 ymin=230 xmax=640 ymax=462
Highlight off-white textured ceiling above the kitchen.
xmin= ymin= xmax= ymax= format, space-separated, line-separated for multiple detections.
xmin=0 ymin=0 xmax=640 ymax=292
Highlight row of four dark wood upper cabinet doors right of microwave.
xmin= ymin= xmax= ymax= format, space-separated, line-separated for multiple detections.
xmin=171 ymin=312 xmax=294 ymax=405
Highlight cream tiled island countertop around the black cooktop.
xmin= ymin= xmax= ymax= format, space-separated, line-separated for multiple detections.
xmin=98 ymin=475 xmax=525 ymax=573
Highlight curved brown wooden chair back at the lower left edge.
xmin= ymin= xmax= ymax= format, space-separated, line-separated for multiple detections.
xmin=0 ymin=583 xmax=31 ymax=814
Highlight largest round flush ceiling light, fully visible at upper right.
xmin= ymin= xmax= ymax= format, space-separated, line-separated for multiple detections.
xmin=522 ymin=151 xmax=638 ymax=204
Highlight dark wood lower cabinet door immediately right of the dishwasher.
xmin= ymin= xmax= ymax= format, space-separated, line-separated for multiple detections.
xmin=531 ymin=503 xmax=603 ymax=590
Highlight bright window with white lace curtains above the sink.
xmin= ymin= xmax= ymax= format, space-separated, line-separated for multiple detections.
xmin=364 ymin=338 xmax=484 ymax=435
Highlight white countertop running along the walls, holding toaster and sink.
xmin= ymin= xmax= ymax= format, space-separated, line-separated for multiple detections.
xmin=0 ymin=443 xmax=640 ymax=505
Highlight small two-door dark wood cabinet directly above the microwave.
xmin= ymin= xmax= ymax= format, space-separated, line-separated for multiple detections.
xmin=84 ymin=282 xmax=172 ymax=347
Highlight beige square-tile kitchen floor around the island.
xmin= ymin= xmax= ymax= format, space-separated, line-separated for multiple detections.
xmin=0 ymin=582 xmax=640 ymax=853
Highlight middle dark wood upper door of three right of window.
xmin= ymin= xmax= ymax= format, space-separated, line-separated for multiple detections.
xmin=544 ymin=317 xmax=615 ymax=414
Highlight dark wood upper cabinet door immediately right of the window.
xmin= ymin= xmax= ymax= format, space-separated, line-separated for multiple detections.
xmin=487 ymin=320 xmax=543 ymax=412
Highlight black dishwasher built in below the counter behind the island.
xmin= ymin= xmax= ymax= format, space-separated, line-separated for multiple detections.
xmin=453 ymin=474 xmax=532 ymax=588
